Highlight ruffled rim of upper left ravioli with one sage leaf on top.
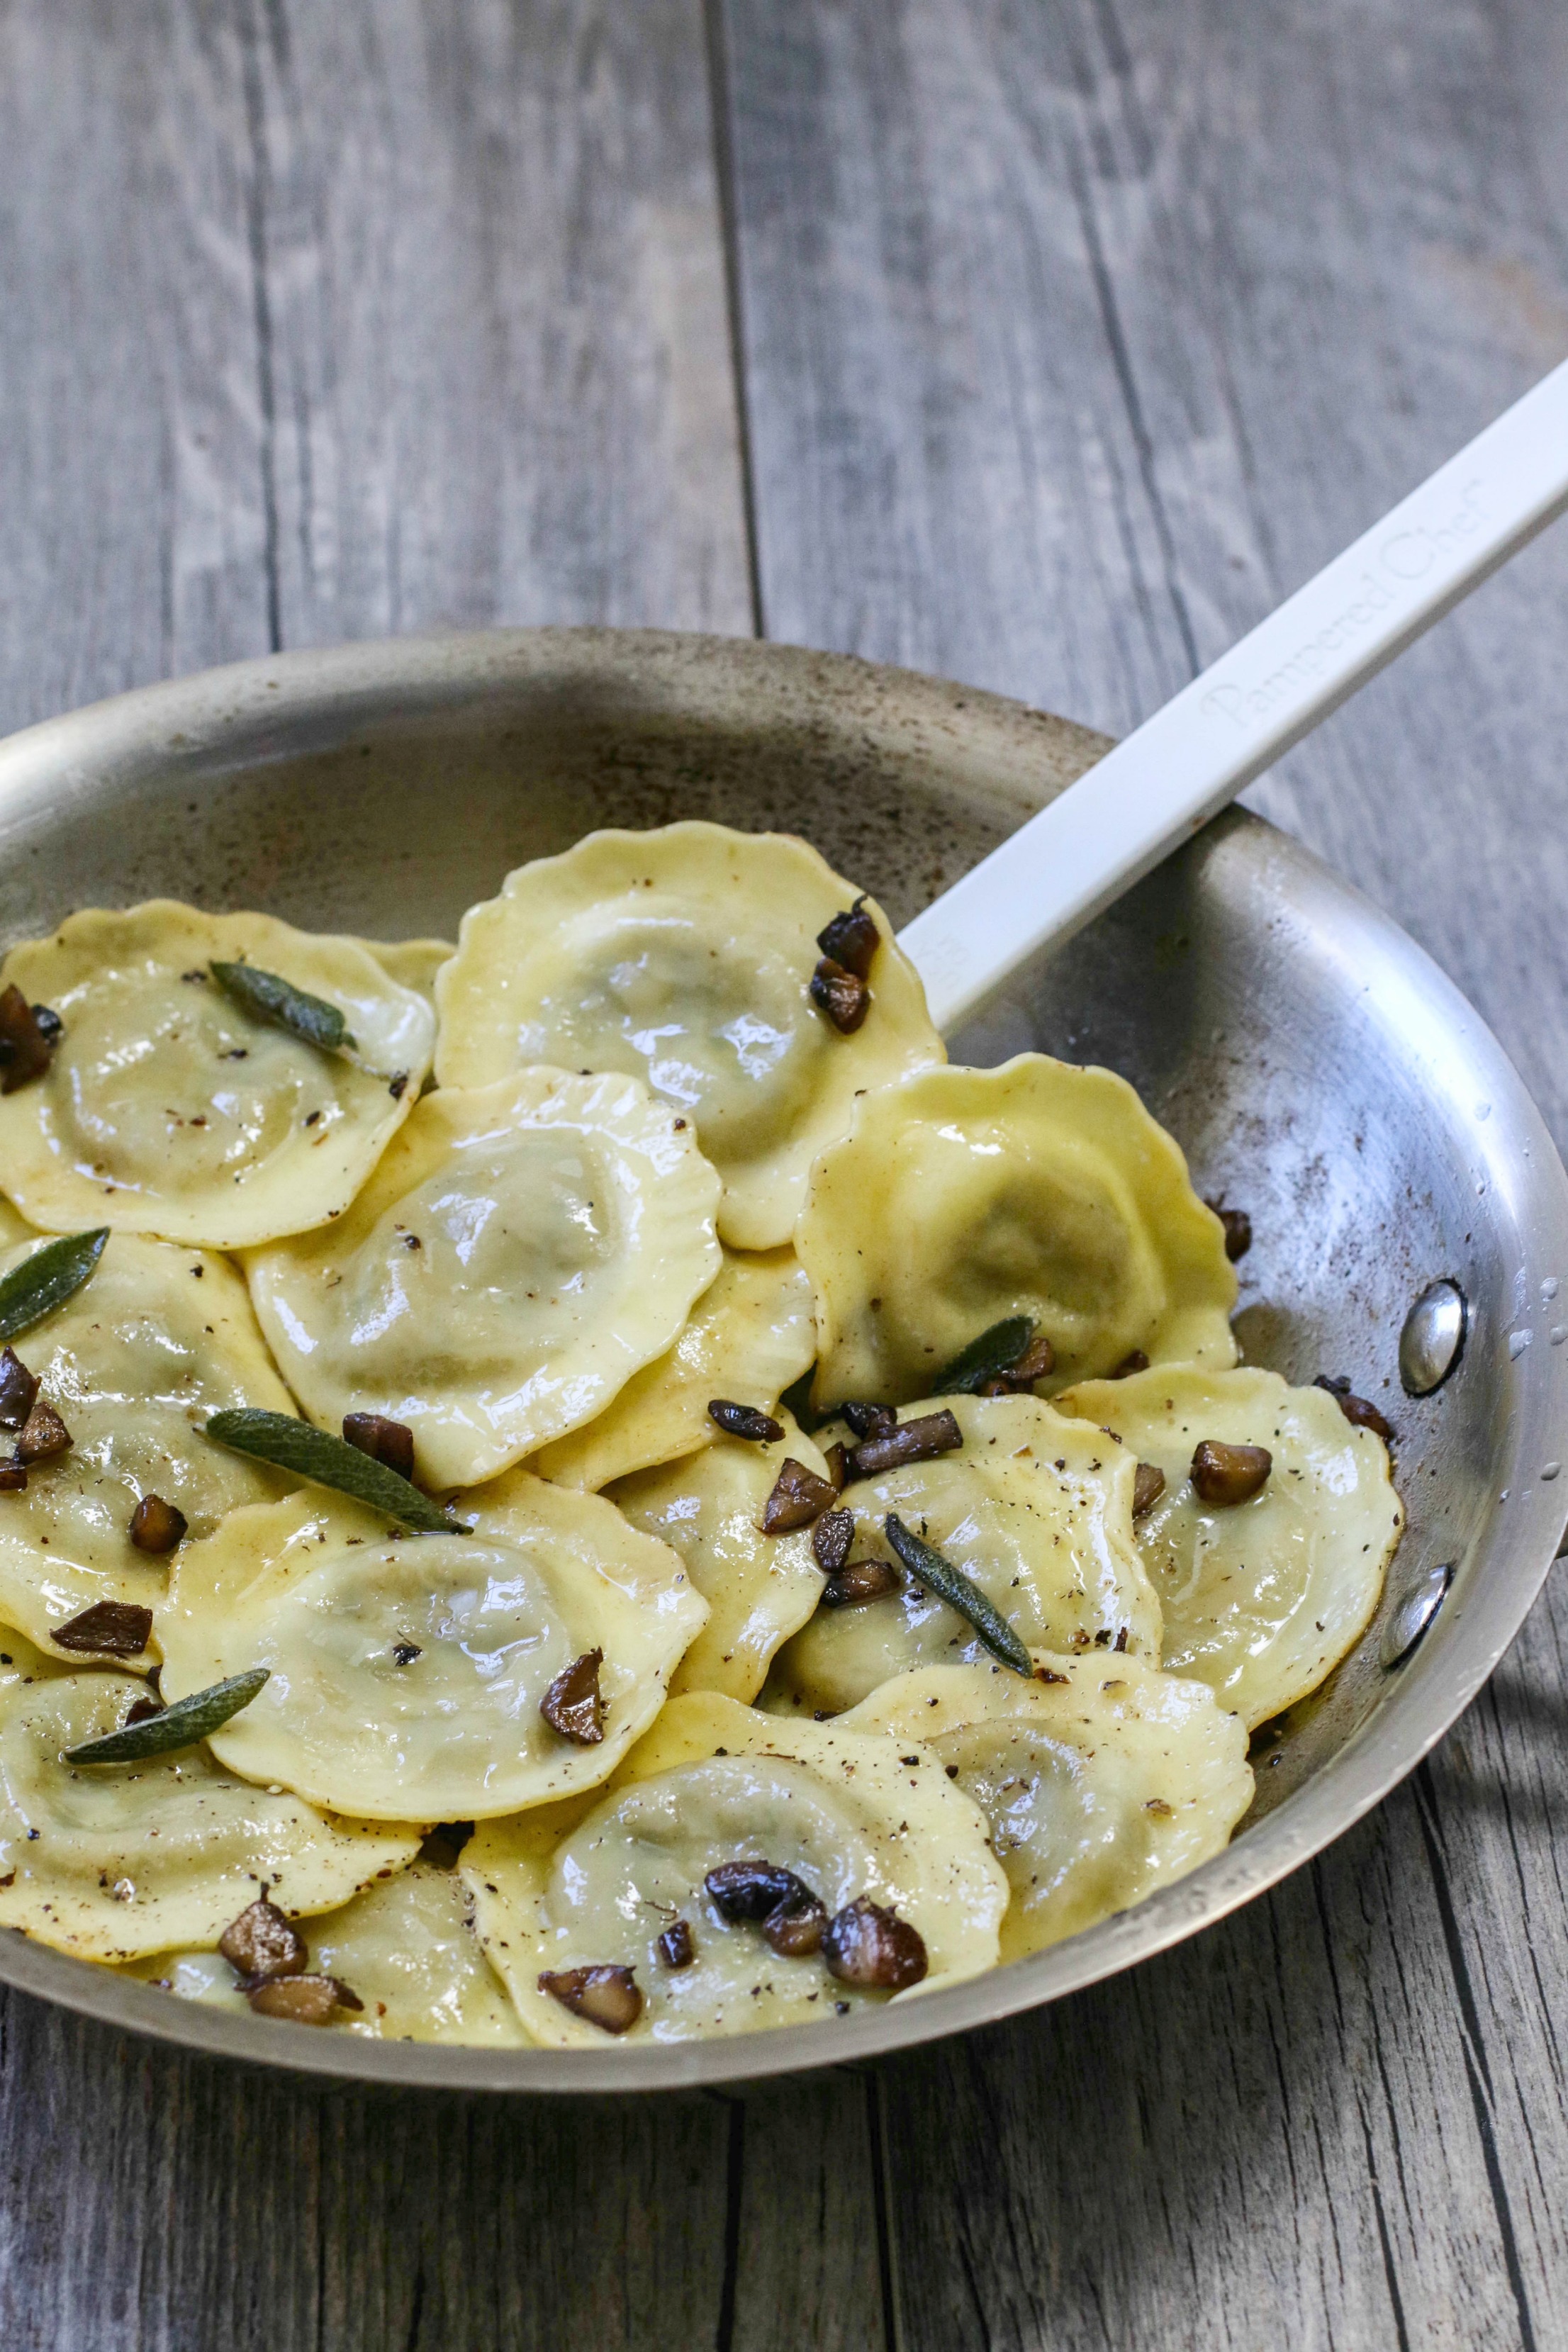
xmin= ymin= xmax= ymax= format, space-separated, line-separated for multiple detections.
xmin=0 ymin=898 xmax=435 ymax=1249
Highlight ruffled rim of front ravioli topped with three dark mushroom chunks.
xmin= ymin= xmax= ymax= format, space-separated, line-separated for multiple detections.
xmin=461 ymin=1691 xmax=1006 ymax=2049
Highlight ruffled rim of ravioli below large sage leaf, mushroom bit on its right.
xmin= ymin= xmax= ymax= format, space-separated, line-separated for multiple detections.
xmin=157 ymin=1470 xmax=707 ymax=1820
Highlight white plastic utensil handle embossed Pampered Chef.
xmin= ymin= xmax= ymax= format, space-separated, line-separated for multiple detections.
xmin=898 ymin=360 xmax=1568 ymax=1033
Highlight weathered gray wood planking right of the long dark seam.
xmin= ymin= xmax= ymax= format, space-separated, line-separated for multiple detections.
xmin=727 ymin=0 xmax=1568 ymax=2352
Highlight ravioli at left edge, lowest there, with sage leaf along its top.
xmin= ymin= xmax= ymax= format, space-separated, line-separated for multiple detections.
xmin=0 ymin=1630 xmax=421 ymax=1959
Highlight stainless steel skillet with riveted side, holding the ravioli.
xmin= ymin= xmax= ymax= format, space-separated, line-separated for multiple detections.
xmin=0 ymin=630 xmax=1568 ymax=2091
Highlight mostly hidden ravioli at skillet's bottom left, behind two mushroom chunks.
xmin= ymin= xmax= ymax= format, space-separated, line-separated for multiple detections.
xmin=122 ymin=1863 xmax=529 ymax=2049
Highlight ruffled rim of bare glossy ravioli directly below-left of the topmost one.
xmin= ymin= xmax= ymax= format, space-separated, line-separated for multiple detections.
xmin=245 ymin=1065 xmax=722 ymax=1486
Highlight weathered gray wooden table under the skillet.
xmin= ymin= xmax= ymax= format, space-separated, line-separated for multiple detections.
xmin=0 ymin=0 xmax=1568 ymax=2352
